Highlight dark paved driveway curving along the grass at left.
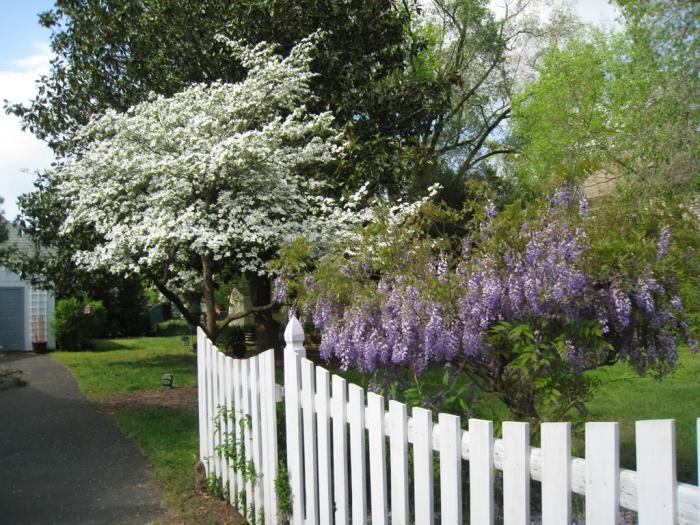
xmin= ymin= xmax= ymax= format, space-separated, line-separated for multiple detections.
xmin=0 ymin=353 xmax=163 ymax=525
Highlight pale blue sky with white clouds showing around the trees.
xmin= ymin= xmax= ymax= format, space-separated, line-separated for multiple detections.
xmin=0 ymin=0 xmax=617 ymax=219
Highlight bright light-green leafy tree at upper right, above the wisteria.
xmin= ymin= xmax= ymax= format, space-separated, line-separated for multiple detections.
xmin=513 ymin=2 xmax=700 ymax=199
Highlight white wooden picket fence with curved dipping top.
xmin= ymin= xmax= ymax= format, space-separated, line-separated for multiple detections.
xmin=197 ymin=318 xmax=700 ymax=525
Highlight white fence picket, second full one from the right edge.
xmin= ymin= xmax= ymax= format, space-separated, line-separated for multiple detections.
xmin=585 ymin=423 xmax=620 ymax=525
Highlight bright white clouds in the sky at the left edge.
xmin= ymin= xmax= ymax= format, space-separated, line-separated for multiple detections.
xmin=0 ymin=42 xmax=53 ymax=219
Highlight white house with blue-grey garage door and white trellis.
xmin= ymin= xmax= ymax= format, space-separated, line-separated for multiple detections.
xmin=0 ymin=218 xmax=55 ymax=351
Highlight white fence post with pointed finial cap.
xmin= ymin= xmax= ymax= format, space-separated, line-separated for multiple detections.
xmin=284 ymin=316 xmax=306 ymax=525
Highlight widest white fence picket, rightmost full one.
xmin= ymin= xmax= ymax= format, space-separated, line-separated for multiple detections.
xmin=635 ymin=419 xmax=677 ymax=525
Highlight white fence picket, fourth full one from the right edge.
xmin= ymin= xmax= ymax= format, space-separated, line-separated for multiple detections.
xmin=503 ymin=421 xmax=530 ymax=525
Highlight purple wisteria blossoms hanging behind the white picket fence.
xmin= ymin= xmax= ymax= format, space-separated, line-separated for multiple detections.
xmin=288 ymin=188 xmax=697 ymax=388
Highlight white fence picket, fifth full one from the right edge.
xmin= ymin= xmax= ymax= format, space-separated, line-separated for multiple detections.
xmin=469 ymin=419 xmax=495 ymax=525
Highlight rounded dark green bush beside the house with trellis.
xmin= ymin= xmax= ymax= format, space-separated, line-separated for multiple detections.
xmin=51 ymin=297 xmax=107 ymax=350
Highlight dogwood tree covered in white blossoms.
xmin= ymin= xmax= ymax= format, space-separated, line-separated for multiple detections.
xmin=56 ymin=36 xmax=357 ymax=339
